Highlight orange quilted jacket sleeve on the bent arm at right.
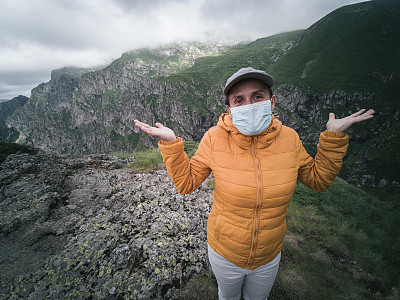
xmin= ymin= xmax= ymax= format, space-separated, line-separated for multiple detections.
xmin=297 ymin=131 xmax=349 ymax=192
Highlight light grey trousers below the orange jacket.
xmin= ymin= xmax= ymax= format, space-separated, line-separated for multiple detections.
xmin=208 ymin=245 xmax=281 ymax=300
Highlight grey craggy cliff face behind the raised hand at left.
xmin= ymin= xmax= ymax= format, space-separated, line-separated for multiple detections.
xmin=9 ymin=43 xmax=236 ymax=154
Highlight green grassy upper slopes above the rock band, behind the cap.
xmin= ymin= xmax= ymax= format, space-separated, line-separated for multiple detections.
xmin=162 ymin=0 xmax=400 ymax=103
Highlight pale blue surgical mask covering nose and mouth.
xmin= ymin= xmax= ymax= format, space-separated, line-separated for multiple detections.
xmin=230 ymin=100 xmax=272 ymax=135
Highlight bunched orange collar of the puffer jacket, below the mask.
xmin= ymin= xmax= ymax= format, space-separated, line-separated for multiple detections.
xmin=217 ymin=113 xmax=282 ymax=149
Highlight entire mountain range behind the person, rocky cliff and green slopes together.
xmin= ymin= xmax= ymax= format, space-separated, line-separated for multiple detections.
xmin=4 ymin=0 xmax=400 ymax=186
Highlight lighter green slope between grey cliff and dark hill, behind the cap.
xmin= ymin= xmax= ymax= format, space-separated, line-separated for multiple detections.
xmin=159 ymin=31 xmax=302 ymax=125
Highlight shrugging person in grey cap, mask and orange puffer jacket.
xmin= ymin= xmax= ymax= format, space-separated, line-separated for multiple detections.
xmin=135 ymin=67 xmax=374 ymax=299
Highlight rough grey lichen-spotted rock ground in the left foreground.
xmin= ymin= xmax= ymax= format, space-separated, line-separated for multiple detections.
xmin=0 ymin=154 xmax=216 ymax=299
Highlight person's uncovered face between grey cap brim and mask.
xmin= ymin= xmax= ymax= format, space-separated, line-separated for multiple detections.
xmin=226 ymin=79 xmax=276 ymax=114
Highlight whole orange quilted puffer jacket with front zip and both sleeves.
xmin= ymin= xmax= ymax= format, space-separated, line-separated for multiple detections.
xmin=159 ymin=114 xmax=348 ymax=270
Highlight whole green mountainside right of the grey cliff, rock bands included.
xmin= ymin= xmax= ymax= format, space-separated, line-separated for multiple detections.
xmin=165 ymin=0 xmax=400 ymax=183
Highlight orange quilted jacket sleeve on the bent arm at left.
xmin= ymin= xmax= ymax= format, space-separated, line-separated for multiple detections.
xmin=158 ymin=133 xmax=211 ymax=194
